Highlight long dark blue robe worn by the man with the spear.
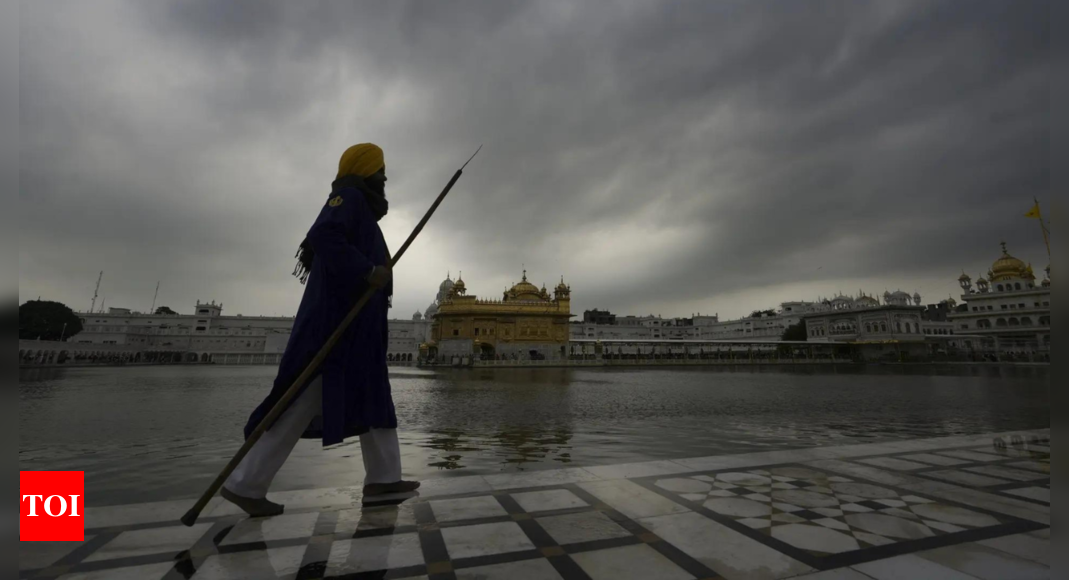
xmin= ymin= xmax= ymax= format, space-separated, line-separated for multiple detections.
xmin=245 ymin=181 xmax=398 ymax=446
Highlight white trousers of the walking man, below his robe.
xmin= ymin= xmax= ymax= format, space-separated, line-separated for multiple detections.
xmin=223 ymin=378 xmax=401 ymax=499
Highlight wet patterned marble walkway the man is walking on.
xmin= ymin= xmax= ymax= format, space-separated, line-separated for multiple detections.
xmin=19 ymin=429 xmax=1051 ymax=580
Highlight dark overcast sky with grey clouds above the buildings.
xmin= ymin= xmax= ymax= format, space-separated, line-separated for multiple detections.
xmin=18 ymin=0 xmax=1060 ymax=317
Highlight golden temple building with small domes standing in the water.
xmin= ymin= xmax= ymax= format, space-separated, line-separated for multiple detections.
xmin=424 ymin=270 xmax=572 ymax=359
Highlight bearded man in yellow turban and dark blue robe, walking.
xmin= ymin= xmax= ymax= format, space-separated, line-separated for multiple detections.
xmin=221 ymin=143 xmax=419 ymax=517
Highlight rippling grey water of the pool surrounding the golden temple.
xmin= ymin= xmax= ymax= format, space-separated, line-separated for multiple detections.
xmin=18 ymin=366 xmax=1050 ymax=505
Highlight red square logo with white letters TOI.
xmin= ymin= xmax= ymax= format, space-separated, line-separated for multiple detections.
xmin=18 ymin=471 xmax=86 ymax=542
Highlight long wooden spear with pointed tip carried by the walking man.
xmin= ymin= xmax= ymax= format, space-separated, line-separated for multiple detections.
xmin=182 ymin=145 xmax=482 ymax=526
